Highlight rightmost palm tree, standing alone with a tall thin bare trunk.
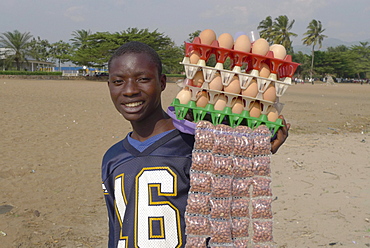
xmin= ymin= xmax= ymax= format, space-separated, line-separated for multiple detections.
xmin=302 ymin=19 xmax=327 ymax=78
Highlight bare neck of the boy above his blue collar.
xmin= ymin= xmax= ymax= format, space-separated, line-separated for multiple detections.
xmin=131 ymin=110 xmax=175 ymax=142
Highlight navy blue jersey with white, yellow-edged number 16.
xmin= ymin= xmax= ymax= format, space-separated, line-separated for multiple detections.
xmin=102 ymin=130 xmax=194 ymax=248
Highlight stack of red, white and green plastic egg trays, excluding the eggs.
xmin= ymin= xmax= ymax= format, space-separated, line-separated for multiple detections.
xmin=171 ymin=37 xmax=299 ymax=136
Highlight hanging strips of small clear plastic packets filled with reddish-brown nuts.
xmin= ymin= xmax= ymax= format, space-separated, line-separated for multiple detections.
xmin=185 ymin=121 xmax=275 ymax=248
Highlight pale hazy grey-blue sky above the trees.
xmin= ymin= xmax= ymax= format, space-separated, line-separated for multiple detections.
xmin=0 ymin=0 xmax=370 ymax=45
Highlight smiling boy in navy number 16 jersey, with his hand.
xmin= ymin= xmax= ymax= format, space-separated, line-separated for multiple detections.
xmin=102 ymin=42 xmax=289 ymax=248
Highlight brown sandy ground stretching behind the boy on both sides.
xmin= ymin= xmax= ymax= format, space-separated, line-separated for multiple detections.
xmin=0 ymin=79 xmax=370 ymax=248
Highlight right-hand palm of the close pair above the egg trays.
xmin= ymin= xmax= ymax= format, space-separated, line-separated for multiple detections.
xmin=272 ymin=15 xmax=297 ymax=53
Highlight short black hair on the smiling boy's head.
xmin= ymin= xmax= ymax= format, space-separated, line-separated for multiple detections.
xmin=108 ymin=41 xmax=162 ymax=75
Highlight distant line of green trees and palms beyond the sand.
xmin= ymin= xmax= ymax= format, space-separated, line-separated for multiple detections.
xmin=0 ymin=15 xmax=370 ymax=78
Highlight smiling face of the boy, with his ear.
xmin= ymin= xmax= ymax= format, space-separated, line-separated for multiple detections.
xmin=108 ymin=53 xmax=166 ymax=122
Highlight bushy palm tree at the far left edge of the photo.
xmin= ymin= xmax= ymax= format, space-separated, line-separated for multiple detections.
xmin=0 ymin=30 xmax=32 ymax=71
